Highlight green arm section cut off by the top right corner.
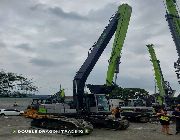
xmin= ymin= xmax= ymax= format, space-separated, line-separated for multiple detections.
xmin=166 ymin=0 xmax=180 ymax=41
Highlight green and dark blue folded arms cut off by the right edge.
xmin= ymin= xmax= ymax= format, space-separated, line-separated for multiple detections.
xmin=165 ymin=0 xmax=180 ymax=84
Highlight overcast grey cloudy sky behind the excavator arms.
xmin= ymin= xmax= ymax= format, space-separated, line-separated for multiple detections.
xmin=0 ymin=0 xmax=180 ymax=95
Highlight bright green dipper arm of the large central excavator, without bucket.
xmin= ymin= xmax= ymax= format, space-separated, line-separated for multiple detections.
xmin=106 ymin=4 xmax=132 ymax=86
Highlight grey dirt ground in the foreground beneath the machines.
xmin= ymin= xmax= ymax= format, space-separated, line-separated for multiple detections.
xmin=0 ymin=116 xmax=180 ymax=140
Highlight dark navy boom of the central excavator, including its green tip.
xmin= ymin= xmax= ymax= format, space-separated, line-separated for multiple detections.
xmin=73 ymin=4 xmax=132 ymax=110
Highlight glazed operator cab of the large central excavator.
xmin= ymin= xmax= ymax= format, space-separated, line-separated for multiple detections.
xmin=88 ymin=94 xmax=110 ymax=113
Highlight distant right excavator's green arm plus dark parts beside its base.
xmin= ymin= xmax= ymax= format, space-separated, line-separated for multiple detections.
xmin=146 ymin=44 xmax=175 ymax=105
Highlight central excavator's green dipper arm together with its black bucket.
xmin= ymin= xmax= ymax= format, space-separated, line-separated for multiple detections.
xmin=87 ymin=1 xmax=130 ymax=99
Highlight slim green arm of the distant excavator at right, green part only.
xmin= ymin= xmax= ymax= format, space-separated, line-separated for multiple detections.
xmin=146 ymin=44 xmax=165 ymax=105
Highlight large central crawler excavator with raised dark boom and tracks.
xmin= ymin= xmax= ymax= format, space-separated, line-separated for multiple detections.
xmin=23 ymin=4 xmax=132 ymax=134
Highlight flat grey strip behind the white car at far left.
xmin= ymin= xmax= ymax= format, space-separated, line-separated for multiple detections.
xmin=0 ymin=98 xmax=32 ymax=111
